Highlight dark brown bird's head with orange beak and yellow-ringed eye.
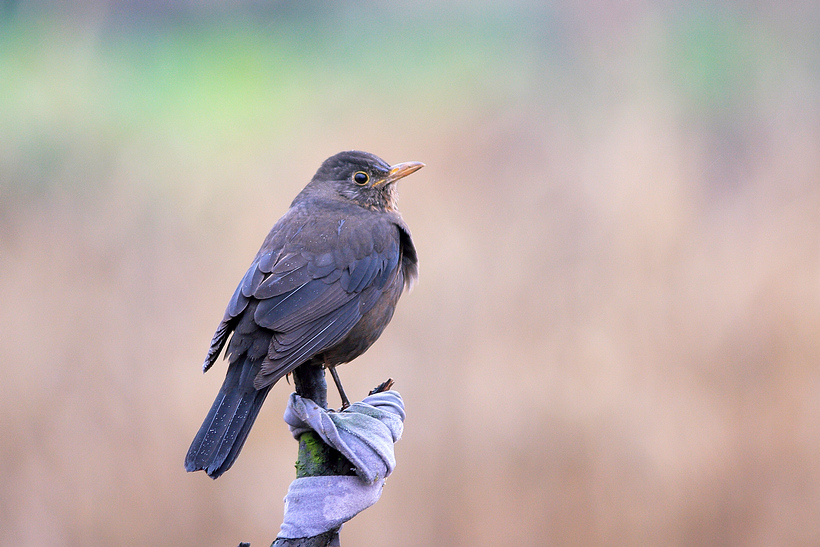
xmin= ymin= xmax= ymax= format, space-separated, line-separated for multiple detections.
xmin=308 ymin=150 xmax=424 ymax=210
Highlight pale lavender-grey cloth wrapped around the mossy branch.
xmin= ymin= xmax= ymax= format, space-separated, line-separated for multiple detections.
xmin=279 ymin=391 xmax=405 ymax=538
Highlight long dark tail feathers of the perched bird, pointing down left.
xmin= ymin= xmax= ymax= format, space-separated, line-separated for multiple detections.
xmin=185 ymin=356 xmax=273 ymax=479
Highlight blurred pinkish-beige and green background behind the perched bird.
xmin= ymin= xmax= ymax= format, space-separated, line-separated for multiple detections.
xmin=0 ymin=0 xmax=820 ymax=547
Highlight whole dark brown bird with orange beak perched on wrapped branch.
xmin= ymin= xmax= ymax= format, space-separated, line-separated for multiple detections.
xmin=185 ymin=150 xmax=424 ymax=479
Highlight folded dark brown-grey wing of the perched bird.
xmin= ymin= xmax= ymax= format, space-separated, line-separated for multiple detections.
xmin=199 ymin=209 xmax=402 ymax=389
